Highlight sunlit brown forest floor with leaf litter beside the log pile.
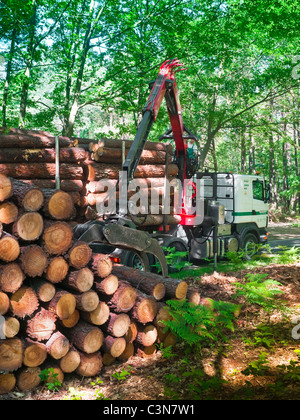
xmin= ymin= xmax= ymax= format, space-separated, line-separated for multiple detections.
xmin=0 ymin=262 xmax=300 ymax=401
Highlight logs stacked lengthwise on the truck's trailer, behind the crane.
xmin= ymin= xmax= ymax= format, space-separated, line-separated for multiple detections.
xmin=0 ymin=128 xmax=180 ymax=226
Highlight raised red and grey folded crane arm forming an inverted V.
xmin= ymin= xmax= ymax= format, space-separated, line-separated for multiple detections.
xmin=122 ymin=59 xmax=186 ymax=181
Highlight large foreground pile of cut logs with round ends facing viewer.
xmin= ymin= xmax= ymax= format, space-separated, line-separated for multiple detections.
xmin=0 ymin=174 xmax=195 ymax=394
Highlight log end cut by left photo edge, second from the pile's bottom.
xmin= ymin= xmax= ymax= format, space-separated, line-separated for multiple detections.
xmin=0 ymin=338 xmax=24 ymax=372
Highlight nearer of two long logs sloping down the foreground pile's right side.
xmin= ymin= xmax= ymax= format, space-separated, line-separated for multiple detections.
xmin=113 ymin=264 xmax=166 ymax=300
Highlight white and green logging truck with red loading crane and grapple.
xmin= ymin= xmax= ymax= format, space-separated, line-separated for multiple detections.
xmin=75 ymin=60 xmax=269 ymax=276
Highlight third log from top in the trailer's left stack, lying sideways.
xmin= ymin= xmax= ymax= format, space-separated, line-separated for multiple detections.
xmin=0 ymin=163 xmax=83 ymax=180
